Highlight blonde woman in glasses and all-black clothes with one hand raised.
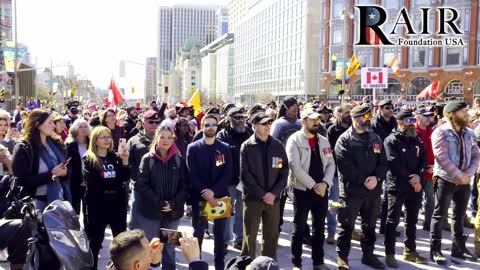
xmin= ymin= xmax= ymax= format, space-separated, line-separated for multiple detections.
xmin=83 ymin=126 xmax=130 ymax=269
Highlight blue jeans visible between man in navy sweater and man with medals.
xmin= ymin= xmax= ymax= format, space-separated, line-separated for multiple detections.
xmin=224 ymin=186 xmax=243 ymax=245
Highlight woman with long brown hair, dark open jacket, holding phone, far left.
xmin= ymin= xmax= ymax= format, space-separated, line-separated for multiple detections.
xmin=11 ymin=109 xmax=71 ymax=213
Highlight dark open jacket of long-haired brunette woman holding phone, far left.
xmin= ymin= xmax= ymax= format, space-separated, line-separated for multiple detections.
xmin=12 ymin=140 xmax=68 ymax=197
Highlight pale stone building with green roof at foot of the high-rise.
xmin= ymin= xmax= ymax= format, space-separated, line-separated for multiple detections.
xmin=166 ymin=38 xmax=202 ymax=102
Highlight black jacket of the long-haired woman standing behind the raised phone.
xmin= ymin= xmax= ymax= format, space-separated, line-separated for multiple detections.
xmin=135 ymin=153 xmax=188 ymax=221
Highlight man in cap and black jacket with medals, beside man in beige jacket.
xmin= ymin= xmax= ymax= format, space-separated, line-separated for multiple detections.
xmin=240 ymin=112 xmax=288 ymax=260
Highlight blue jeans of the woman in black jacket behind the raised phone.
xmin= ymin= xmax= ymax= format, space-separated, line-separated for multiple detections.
xmin=128 ymin=192 xmax=180 ymax=270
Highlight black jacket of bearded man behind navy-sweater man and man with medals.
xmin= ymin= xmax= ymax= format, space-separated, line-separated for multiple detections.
xmin=217 ymin=126 xmax=253 ymax=186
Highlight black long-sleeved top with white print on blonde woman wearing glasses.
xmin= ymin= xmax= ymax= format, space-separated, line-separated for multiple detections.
xmin=83 ymin=151 xmax=130 ymax=207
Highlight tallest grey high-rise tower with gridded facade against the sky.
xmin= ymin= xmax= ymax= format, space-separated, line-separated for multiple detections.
xmin=157 ymin=5 xmax=228 ymax=76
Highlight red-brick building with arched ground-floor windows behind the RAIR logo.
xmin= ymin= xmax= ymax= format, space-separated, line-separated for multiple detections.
xmin=319 ymin=0 xmax=480 ymax=103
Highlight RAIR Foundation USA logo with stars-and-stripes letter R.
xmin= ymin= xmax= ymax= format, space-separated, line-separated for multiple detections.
xmin=355 ymin=6 xmax=464 ymax=46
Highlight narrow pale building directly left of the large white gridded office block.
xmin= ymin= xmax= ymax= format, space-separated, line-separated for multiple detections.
xmin=200 ymin=33 xmax=234 ymax=102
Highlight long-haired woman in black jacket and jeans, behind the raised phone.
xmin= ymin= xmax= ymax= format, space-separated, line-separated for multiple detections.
xmin=130 ymin=125 xmax=188 ymax=270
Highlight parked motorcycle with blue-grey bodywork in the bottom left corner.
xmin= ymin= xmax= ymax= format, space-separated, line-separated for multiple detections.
xmin=2 ymin=178 xmax=93 ymax=270
